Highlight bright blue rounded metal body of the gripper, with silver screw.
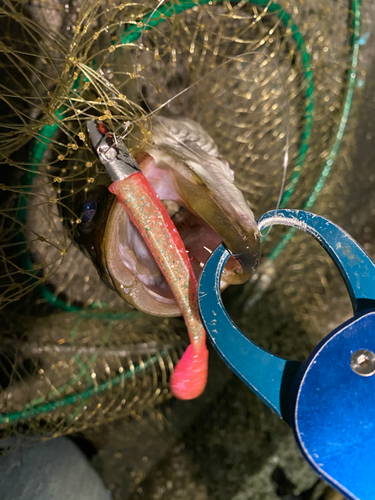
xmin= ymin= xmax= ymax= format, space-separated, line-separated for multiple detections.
xmin=291 ymin=311 xmax=375 ymax=500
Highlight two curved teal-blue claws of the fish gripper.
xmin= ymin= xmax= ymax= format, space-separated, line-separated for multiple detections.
xmin=198 ymin=210 xmax=375 ymax=422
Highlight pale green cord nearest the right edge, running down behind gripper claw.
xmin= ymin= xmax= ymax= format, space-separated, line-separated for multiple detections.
xmin=268 ymin=0 xmax=361 ymax=260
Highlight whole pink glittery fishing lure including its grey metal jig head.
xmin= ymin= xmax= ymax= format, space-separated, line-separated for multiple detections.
xmin=87 ymin=120 xmax=208 ymax=399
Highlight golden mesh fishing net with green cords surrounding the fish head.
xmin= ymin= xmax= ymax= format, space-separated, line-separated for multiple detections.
xmin=0 ymin=0 xmax=373 ymax=496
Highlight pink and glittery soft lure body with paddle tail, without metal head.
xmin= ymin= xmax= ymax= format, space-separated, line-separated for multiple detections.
xmin=109 ymin=172 xmax=208 ymax=399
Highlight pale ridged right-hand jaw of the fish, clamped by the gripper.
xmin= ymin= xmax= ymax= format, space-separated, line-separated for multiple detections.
xmin=148 ymin=116 xmax=260 ymax=274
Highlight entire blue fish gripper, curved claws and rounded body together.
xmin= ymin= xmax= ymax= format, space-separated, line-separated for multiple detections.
xmin=198 ymin=210 xmax=375 ymax=500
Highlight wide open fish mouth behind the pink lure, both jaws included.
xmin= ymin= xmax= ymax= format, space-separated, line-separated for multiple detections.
xmin=102 ymin=118 xmax=260 ymax=316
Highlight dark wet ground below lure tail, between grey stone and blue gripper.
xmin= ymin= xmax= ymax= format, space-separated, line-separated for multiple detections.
xmin=85 ymin=346 xmax=325 ymax=500
